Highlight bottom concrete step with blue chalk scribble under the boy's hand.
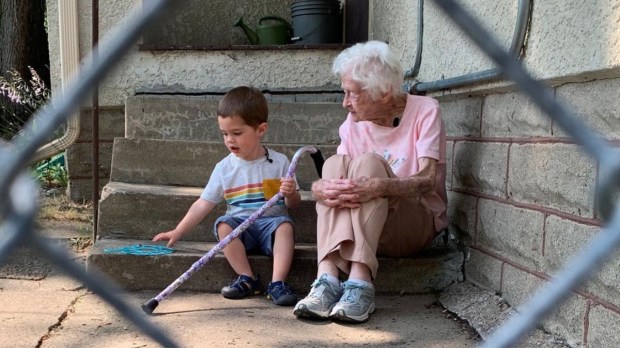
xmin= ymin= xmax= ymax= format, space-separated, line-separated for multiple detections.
xmin=88 ymin=239 xmax=464 ymax=294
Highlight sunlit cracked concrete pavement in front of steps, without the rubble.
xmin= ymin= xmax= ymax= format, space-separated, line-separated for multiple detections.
xmin=0 ymin=271 xmax=476 ymax=347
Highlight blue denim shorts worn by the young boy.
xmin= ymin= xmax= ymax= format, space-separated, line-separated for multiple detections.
xmin=213 ymin=215 xmax=293 ymax=256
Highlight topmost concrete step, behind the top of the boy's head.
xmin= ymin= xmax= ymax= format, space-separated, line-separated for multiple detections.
xmin=125 ymin=95 xmax=347 ymax=145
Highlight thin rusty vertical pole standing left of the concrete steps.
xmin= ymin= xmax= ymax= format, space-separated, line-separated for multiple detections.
xmin=92 ymin=0 xmax=99 ymax=241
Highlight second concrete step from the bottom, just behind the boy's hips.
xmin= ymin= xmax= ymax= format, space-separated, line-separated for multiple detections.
xmin=98 ymin=182 xmax=316 ymax=243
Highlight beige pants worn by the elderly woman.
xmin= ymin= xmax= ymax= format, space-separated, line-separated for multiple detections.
xmin=316 ymin=154 xmax=436 ymax=279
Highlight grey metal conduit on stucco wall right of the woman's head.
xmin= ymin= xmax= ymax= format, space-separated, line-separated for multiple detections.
xmin=405 ymin=0 xmax=532 ymax=94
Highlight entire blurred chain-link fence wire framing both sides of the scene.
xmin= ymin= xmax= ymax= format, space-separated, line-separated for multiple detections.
xmin=0 ymin=0 xmax=620 ymax=347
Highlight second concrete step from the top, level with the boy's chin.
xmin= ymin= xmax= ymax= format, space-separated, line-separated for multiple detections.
xmin=110 ymin=138 xmax=336 ymax=190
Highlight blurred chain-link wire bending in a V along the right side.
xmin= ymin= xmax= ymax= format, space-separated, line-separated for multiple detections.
xmin=435 ymin=0 xmax=620 ymax=347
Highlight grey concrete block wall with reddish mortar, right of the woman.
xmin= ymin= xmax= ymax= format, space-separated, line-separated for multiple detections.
xmin=439 ymin=79 xmax=620 ymax=347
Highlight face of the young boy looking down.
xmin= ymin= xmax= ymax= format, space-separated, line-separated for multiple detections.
xmin=217 ymin=116 xmax=267 ymax=161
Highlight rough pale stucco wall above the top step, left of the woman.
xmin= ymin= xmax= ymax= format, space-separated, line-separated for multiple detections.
xmin=48 ymin=0 xmax=339 ymax=106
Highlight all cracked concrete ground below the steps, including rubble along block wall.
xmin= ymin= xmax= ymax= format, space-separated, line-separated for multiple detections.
xmin=0 ymin=220 xmax=567 ymax=348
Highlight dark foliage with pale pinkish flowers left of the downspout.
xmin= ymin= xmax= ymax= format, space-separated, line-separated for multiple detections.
xmin=0 ymin=66 xmax=51 ymax=140
